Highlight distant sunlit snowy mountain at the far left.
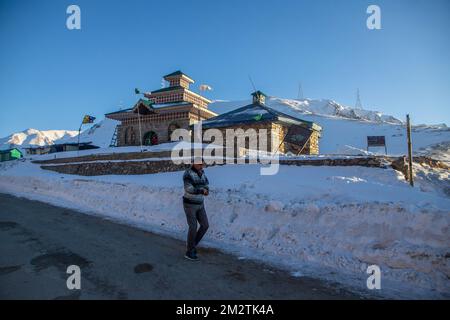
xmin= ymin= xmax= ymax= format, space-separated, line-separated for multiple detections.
xmin=0 ymin=129 xmax=78 ymax=149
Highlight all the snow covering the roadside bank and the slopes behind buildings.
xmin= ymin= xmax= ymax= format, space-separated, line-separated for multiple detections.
xmin=0 ymin=97 xmax=450 ymax=298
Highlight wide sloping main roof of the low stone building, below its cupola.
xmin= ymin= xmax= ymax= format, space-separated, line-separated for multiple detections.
xmin=202 ymin=103 xmax=322 ymax=131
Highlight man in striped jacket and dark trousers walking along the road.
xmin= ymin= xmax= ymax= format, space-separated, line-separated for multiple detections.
xmin=183 ymin=159 xmax=209 ymax=261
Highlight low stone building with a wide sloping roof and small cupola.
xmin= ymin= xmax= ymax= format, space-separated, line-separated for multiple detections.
xmin=202 ymin=91 xmax=322 ymax=155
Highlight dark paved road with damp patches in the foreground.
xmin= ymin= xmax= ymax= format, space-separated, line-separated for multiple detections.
xmin=0 ymin=194 xmax=358 ymax=299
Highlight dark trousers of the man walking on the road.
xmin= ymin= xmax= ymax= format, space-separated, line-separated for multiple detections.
xmin=183 ymin=202 xmax=209 ymax=251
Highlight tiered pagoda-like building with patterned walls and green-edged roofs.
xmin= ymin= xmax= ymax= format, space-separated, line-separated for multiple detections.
xmin=105 ymin=71 xmax=217 ymax=146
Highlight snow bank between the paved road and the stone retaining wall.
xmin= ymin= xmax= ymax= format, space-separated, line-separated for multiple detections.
xmin=0 ymin=160 xmax=450 ymax=298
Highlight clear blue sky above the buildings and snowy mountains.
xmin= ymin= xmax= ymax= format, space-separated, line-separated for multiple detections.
xmin=0 ymin=0 xmax=450 ymax=137
